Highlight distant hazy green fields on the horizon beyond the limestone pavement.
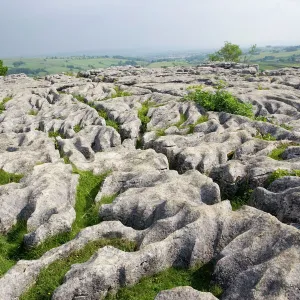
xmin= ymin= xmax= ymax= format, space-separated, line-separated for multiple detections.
xmin=3 ymin=46 xmax=300 ymax=76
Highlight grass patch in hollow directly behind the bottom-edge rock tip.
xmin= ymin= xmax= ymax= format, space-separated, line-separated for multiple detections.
xmin=105 ymin=262 xmax=223 ymax=300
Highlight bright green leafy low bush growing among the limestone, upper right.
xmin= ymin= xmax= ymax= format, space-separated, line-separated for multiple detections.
xmin=185 ymin=88 xmax=253 ymax=118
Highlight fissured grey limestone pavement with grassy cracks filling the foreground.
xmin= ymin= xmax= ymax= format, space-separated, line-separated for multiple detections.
xmin=0 ymin=63 xmax=300 ymax=300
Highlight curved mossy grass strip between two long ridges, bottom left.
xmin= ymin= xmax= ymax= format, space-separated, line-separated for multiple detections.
xmin=20 ymin=239 xmax=136 ymax=300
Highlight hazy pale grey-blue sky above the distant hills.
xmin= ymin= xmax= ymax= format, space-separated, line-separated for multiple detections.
xmin=0 ymin=0 xmax=300 ymax=57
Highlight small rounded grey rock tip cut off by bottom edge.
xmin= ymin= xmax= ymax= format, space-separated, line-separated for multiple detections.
xmin=155 ymin=286 xmax=218 ymax=300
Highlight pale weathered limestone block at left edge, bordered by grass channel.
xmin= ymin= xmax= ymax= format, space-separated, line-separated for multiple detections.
xmin=0 ymin=163 xmax=78 ymax=246
